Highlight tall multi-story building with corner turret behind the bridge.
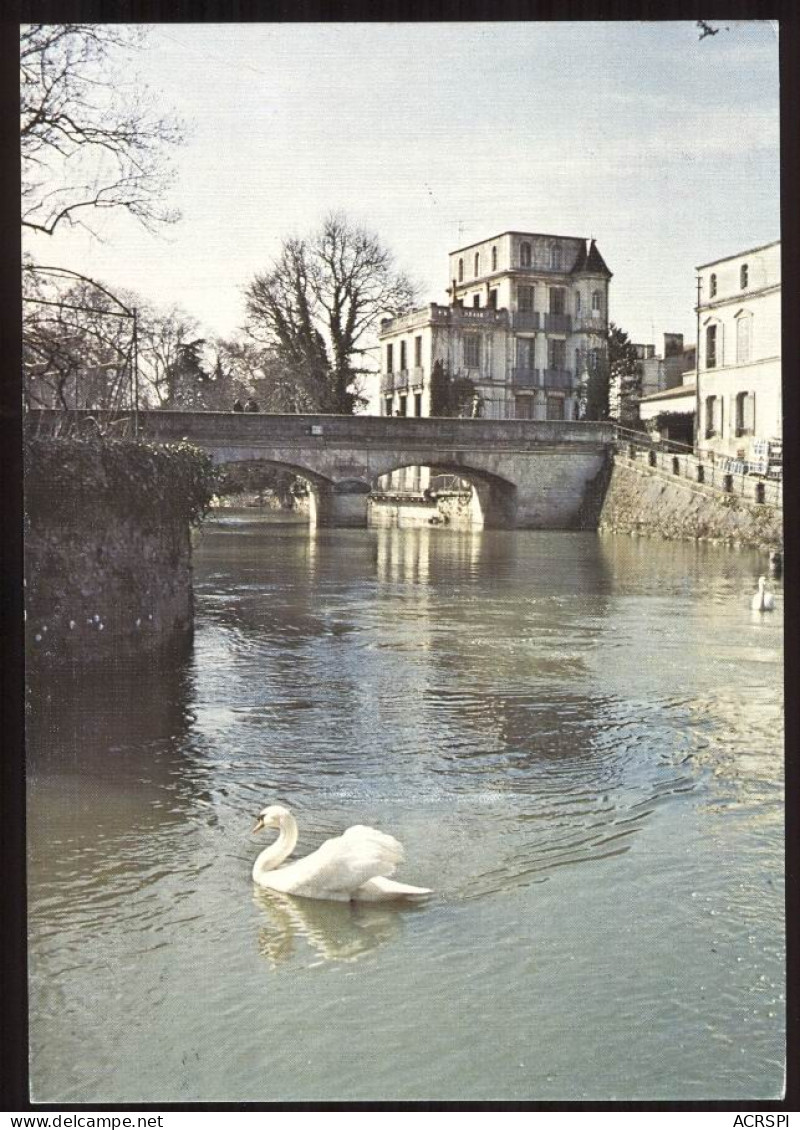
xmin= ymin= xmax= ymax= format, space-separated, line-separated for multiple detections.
xmin=380 ymin=232 xmax=611 ymax=419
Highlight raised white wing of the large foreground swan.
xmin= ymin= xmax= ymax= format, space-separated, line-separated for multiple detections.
xmin=276 ymin=824 xmax=403 ymax=897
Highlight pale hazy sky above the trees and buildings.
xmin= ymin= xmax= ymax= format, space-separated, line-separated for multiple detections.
xmin=29 ymin=20 xmax=780 ymax=370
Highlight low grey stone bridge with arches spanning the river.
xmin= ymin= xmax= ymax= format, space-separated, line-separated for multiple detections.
xmin=29 ymin=411 xmax=614 ymax=530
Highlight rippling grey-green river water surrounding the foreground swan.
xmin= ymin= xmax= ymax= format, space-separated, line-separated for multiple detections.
xmin=28 ymin=512 xmax=785 ymax=1103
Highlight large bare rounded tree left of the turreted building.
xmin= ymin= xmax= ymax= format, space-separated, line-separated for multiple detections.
xmin=246 ymin=212 xmax=416 ymax=412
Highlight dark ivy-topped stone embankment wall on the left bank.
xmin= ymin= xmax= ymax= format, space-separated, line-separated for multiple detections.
xmin=25 ymin=438 xmax=214 ymax=667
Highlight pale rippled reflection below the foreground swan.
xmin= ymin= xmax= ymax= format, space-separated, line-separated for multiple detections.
xmin=253 ymin=888 xmax=414 ymax=968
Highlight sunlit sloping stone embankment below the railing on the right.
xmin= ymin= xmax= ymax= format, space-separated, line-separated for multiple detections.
xmin=598 ymin=455 xmax=783 ymax=550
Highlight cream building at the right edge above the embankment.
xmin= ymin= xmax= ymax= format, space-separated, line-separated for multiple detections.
xmin=697 ymin=240 xmax=781 ymax=460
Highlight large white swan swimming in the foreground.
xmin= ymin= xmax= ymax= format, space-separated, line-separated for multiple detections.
xmin=253 ymin=805 xmax=432 ymax=903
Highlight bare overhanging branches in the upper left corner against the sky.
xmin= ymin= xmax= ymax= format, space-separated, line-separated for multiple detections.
xmin=20 ymin=24 xmax=182 ymax=235
